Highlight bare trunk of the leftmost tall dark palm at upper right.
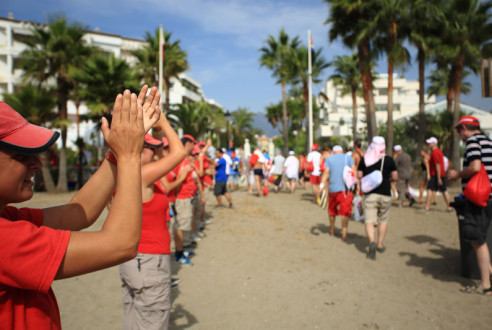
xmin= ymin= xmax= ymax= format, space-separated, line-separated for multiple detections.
xmin=357 ymin=40 xmax=377 ymax=141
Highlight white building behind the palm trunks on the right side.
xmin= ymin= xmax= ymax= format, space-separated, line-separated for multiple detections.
xmin=315 ymin=74 xmax=436 ymax=138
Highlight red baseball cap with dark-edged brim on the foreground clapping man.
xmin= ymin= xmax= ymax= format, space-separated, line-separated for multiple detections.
xmin=0 ymin=101 xmax=60 ymax=155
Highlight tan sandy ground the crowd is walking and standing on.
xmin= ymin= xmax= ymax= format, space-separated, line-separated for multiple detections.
xmin=19 ymin=186 xmax=492 ymax=329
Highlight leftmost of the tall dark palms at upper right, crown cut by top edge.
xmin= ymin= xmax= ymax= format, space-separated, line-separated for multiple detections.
xmin=324 ymin=0 xmax=378 ymax=139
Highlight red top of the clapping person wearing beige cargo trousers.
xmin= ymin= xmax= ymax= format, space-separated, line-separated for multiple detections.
xmin=138 ymin=182 xmax=171 ymax=254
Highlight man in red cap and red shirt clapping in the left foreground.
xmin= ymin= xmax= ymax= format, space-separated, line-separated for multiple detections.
xmin=0 ymin=86 xmax=160 ymax=329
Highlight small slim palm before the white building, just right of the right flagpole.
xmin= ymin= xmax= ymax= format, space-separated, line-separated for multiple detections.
xmin=329 ymin=53 xmax=362 ymax=142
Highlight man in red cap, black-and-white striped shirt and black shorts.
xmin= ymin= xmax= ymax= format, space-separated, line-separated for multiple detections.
xmin=448 ymin=116 xmax=492 ymax=295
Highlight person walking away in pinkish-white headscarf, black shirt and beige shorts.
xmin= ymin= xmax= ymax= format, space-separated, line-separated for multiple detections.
xmin=357 ymin=136 xmax=398 ymax=260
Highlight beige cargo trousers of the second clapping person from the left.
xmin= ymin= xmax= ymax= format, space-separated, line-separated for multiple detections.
xmin=120 ymin=253 xmax=171 ymax=329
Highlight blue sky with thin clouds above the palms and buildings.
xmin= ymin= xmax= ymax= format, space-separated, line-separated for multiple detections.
xmin=0 ymin=0 xmax=492 ymax=113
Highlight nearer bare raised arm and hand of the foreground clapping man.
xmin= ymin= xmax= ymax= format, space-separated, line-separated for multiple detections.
xmin=53 ymin=90 xmax=145 ymax=279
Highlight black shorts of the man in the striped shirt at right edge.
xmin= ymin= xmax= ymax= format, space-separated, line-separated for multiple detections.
xmin=462 ymin=200 xmax=492 ymax=244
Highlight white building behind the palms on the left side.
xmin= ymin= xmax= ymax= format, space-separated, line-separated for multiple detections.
xmin=0 ymin=14 xmax=221 ymax=147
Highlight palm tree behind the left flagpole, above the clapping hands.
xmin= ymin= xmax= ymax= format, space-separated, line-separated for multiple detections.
xmin=133 ymin=28 xmax=189 ymax=112
